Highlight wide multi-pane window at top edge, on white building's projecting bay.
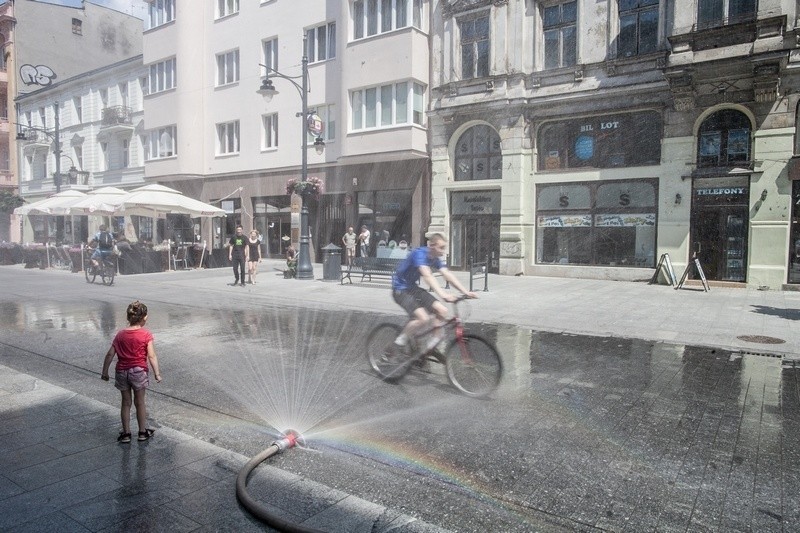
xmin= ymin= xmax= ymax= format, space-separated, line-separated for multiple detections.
xmin=353 ymin=0 xmax=422 ymax=39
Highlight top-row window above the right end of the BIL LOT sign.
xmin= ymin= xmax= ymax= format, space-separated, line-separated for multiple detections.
xmin=617 ymin=0 xmax=658 ymax=57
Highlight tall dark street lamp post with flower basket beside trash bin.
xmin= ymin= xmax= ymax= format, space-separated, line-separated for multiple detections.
xmin=258 ymin=35 xmax=325 ymax=279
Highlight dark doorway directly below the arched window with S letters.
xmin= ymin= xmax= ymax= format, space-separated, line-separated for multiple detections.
xmin=448 ymin=190 xmax=500 ymax=274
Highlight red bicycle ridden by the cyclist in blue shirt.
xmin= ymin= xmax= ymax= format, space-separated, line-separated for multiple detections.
xmin=366 ymin=296 xmax=503 ymax=398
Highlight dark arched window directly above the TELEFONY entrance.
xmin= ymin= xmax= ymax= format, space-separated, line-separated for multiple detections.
xmin=697 ymin=109 xmax=750 ymax=168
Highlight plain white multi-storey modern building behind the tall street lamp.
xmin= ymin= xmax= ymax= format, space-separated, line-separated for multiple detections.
xmin=144 ymin=0 xmax=430 ymax=257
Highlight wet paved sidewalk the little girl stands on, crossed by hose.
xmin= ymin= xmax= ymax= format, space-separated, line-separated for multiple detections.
xmin=0 ymin=365 xmax=444 ymax=533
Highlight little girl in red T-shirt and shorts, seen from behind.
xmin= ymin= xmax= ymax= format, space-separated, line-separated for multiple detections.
xmin=100 ymin=300 xmax=161 ymax=443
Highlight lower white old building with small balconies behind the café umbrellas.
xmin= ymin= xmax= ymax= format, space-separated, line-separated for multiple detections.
xmin=15 ymin=55 xmax=147 ymax=243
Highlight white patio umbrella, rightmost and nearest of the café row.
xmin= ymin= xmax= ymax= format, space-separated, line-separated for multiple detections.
xmin=115 ymin=183 xmax=225 ymax=218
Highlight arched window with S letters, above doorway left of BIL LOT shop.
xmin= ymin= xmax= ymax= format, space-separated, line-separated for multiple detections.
xmin=455 ymin=125 xmax=503 ymax=181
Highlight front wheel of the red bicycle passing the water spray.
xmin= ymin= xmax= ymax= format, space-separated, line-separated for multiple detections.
xmin=445 ymin=334 xmax=503 ymax=398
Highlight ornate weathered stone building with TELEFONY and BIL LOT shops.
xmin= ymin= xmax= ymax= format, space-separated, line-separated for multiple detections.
xmin=429 ymin=0 xmax=800 ymax=288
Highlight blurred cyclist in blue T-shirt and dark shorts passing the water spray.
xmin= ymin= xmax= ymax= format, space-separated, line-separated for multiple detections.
xmin=392 ymin=231 xmax=478 ymax=358
